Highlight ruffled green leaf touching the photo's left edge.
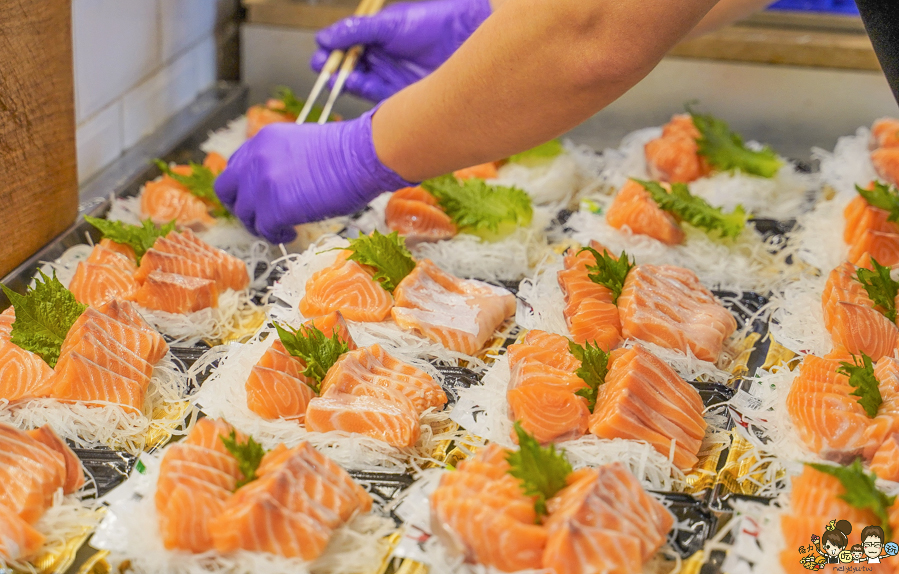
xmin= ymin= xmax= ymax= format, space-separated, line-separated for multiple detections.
xmin=0 ymin=271 xmax=87 ymax=367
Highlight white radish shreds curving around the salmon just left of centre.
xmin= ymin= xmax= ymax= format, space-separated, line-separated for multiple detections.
xmin=189 ymin=333 xmax=463 ymax=470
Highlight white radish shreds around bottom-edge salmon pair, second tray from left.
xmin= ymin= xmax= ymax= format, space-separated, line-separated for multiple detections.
xmin=91 ymin=452 xmax=395 ymax=574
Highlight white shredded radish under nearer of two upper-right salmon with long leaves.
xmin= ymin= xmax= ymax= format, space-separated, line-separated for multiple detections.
xmin=565 ymin=196 xmax=796 ymax=293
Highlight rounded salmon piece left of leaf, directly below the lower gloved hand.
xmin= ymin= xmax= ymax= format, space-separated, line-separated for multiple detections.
xmin=300 ymin=251 xmax=393 ymax=322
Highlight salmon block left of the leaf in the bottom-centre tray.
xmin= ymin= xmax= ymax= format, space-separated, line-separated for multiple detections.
xmin=430 ymin=444 xmax=546 ymax=572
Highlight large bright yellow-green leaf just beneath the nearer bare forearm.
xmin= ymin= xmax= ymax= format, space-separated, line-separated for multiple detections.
xmin=421 ymin=174 xmax=534 ymax=238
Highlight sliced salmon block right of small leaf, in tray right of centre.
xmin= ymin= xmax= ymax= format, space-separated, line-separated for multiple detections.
xmin=589 ymin=345 xmax=707 ymax=470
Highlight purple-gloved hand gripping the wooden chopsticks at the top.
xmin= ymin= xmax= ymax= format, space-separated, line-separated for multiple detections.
xmin=311 ymin=0 xmax=491 ymax=102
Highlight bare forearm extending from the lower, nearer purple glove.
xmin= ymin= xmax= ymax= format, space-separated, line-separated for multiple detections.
xmin=373 ymin=0 xmax=715 ymax=181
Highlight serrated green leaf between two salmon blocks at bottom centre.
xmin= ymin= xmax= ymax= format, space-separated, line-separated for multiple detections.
xmin=506 ymin=422 xmax=572 ymax=520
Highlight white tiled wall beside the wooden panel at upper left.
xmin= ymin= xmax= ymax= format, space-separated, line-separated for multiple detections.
xmin=72 ymin=0 xmax=220 ymax=182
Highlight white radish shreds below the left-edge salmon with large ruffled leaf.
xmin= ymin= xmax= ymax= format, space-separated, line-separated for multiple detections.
xmin=0 ymin=354 xmax=188 ymax=455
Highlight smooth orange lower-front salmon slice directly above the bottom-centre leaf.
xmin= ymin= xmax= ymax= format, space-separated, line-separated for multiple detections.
xmin=506 ymin=383 xmax=590 ymax=444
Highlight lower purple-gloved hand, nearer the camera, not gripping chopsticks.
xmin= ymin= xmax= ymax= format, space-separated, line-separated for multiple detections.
xmin=215 ymin=110 xmax=414 ymax=243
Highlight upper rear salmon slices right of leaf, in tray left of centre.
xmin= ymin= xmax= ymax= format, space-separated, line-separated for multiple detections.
xmin=321 ymin=345 xmax=447 ymax=415
